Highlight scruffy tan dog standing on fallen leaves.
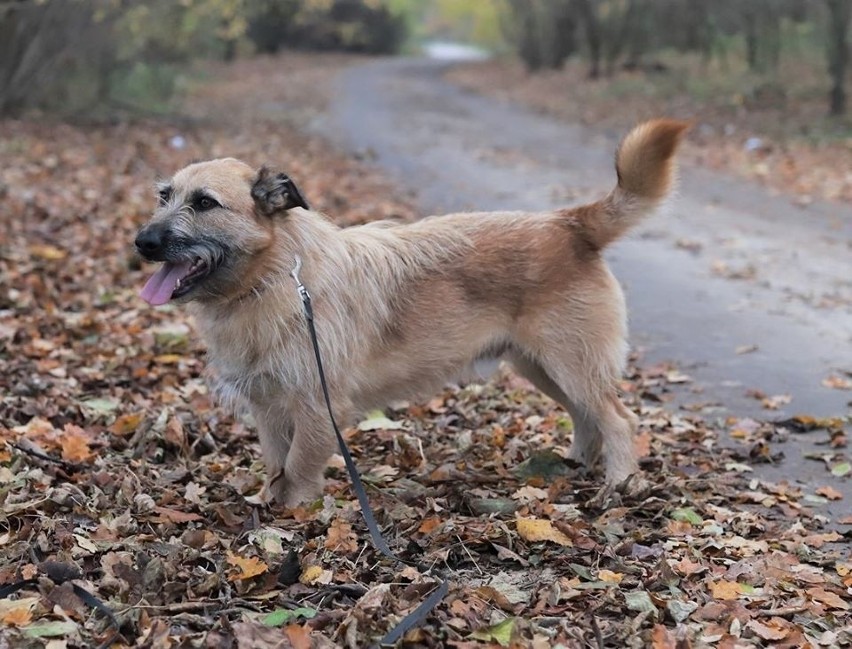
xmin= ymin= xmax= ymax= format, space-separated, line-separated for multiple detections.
xmin=136 ymin=120 xmax=687 ymax=506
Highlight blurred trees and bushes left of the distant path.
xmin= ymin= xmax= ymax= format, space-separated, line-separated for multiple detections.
xmin=0 ymin=0 xmax=407 ymax=114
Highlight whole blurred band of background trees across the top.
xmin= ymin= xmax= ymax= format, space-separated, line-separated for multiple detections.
xmin=0 ymin=0 xmax=852 ymax=115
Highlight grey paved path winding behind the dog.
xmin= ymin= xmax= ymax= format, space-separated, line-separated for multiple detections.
xmin=318 ymin=59 xmax=852 ymax=512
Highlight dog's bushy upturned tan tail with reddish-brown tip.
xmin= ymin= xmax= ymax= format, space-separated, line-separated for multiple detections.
xmin=564 ymin=119 xmax=690 ymax=249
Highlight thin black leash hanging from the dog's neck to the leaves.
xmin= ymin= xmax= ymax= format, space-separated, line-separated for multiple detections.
xmin=290 ymin=257 xmax=449 ymax=646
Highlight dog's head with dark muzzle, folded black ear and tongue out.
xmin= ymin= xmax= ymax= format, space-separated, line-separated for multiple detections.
xmin=136 ymin=158 xmax=308 ymax=305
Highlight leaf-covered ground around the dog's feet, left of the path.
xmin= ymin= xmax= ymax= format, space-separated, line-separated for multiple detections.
xmin=0 ymin=55 xmax=852 ymax=649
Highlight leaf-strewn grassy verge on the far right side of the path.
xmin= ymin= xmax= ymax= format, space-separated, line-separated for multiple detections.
xmin=448 ymin=54 xmax=852 ymax=205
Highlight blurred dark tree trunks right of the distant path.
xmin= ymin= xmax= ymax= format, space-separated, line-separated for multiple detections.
xmin=501 ymin=0 xmax=852 ymax=115
